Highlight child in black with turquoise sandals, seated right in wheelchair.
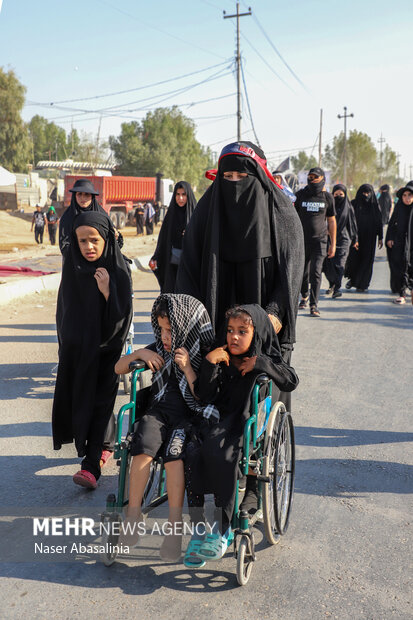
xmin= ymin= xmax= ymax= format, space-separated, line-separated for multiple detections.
xmin=184 ymin=304 xmax=298 ymax=567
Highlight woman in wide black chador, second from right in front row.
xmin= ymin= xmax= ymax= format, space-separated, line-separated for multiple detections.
xmin=344 ymin=183 xmax=383 ymax=292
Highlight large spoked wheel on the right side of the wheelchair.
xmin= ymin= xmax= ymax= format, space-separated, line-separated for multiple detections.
xmin=262 ymin=402 xmax=295 ymax=545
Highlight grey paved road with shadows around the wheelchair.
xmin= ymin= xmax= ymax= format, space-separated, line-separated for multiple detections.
xmin=0 ymin=256 xmax=413 ymax=620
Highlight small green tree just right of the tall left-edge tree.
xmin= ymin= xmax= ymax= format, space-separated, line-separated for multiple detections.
xmin=28 ymin=114 xmax=67 ymax=165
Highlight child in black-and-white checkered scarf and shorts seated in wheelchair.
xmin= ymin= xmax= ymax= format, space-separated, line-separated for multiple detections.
xmin=115 ymin=294 xmax=219 ymax=561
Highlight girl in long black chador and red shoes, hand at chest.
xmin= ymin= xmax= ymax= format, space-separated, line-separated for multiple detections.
xmin=52 ymin=211 xmax=132 ymax=489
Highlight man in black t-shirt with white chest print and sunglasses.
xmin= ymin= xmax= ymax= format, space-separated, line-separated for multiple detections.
xmin=295 ymin=168 xmax=337 ymax=317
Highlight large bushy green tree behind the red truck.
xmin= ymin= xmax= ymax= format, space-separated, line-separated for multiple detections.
xmin=109 ymin=106 xmax=211 ymax=191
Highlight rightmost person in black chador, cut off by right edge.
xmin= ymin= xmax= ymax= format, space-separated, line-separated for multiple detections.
xmin=386 ymin=184 xmax=413 ymax=304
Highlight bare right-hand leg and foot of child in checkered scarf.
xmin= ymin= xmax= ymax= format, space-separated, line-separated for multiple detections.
xmin=160 ymin=460 xmax=185 ymax=562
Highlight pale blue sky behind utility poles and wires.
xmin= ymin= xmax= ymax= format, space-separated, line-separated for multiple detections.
xmin=0 ymin=0 xmax=413 ymax=182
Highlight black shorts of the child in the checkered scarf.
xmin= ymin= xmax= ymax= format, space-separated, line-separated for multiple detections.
xmin=130 ymin=405 xmax=193 ymax=463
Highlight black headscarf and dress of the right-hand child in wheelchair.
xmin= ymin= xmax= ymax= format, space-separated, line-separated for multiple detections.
xmin=185 ymin=304 xmax=298 ymax=523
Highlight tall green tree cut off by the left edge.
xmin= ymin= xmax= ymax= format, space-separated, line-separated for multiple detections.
xmin=0 ymin=68 xmax=31 ymax=172
